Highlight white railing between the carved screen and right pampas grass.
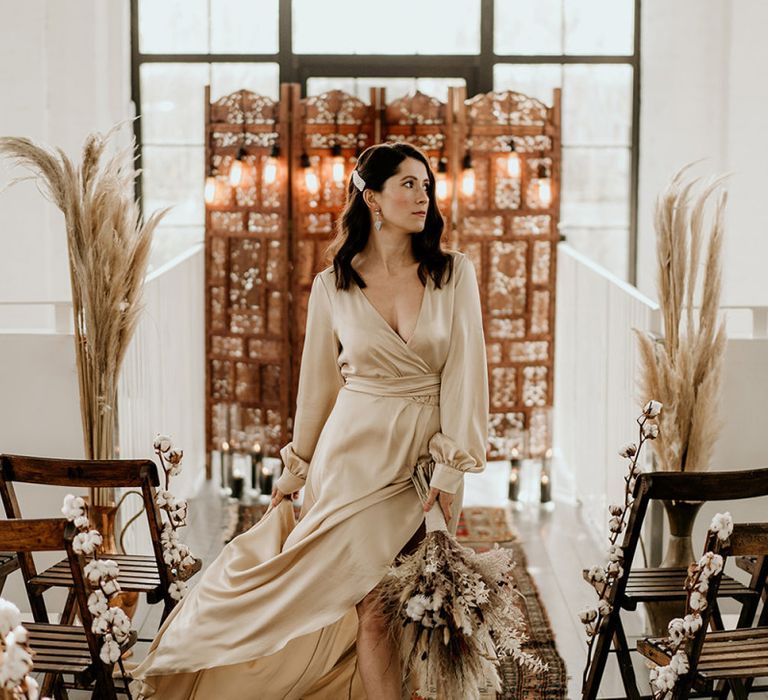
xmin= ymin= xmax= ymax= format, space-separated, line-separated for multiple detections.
xmin=553 ymin=244 xmax=658 ymax=537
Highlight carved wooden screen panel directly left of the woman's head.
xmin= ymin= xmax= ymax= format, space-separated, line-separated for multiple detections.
xmin=290 ymin=85 xmax=380 ymax=404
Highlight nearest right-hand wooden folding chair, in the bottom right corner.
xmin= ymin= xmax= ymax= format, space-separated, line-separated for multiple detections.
xmin=637 ymin=523 xmax=768 ymax=700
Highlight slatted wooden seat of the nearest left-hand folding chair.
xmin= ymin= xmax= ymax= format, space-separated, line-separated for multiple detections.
xmin=24 ymin=622 xmax=137 ymax=674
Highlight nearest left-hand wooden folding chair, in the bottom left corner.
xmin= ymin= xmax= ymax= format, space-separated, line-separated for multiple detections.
xmin=0 ymin=518 xmax=136 ymax=700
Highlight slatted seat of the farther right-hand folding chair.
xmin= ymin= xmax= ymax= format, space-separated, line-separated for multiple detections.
xmin=582 ymin=568 xmax=757 ymax=610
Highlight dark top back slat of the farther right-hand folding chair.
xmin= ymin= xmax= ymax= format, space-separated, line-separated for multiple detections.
xmin=639 ymin=468 xmax=768 ymax=501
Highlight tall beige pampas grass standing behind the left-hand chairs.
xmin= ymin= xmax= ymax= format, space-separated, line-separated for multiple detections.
xmin=0 ymin=125 xmax=166 ymax=505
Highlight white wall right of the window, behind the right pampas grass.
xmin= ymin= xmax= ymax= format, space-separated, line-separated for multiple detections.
xmin=638 ymin=0 xmax=768 ymax=306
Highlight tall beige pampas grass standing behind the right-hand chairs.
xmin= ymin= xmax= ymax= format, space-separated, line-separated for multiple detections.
xmin=636 ymin=164 xmax=727 ymax=471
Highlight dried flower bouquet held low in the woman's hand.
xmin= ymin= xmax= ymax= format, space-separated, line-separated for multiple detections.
xmin=377 ymin=460 xmax=546 ymax=700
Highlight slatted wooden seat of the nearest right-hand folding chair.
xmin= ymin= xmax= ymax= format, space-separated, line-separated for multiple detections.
xmin=637 ymin=627 xmax=768 ymax=683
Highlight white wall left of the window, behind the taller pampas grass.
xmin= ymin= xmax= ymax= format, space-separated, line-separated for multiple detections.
xmin=0 ymin=0 xmax=132 ymax=306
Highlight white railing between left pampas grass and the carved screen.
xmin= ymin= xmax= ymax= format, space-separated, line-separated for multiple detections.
xmin=118 ymin=245 xmax=205 ymax=500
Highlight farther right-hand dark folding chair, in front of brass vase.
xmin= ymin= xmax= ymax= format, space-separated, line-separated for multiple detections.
xmin=582 ymin=469 xmax=768 ymax=700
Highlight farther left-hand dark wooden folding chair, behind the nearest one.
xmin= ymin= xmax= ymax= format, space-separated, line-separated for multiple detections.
xmin=0 ymin=455 xmax=201 ymax=622
